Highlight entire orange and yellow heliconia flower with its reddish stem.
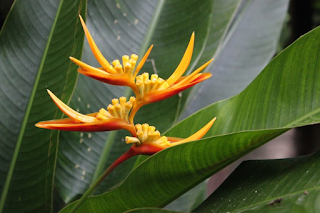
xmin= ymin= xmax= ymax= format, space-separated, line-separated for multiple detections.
xmin=36 ymin=16 xmax=216 ymax=211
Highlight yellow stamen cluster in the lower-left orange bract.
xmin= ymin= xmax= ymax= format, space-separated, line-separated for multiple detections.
xmin=96 ymin=97 xmax=136 ymax=122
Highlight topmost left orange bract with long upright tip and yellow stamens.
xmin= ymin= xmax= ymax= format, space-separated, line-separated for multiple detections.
xmin=70 ymin=16 xmax=153 ymax=96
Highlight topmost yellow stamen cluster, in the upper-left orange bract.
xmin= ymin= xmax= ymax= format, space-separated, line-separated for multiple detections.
xmin=107 ymin=54 xmax=138 ymax=76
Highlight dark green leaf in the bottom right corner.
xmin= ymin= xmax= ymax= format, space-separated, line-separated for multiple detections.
xmin=193 ymin=152 xmax=320 ymax=213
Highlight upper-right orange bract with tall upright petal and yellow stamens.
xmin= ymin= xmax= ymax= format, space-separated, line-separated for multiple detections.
xmin=130 ymin=33 xmax=213 ymax=122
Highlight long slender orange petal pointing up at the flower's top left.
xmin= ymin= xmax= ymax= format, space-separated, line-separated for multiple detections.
xmin=79 ymin=15 xmax=112 ymax=72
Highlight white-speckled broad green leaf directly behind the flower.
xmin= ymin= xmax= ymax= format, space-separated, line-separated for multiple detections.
xmin=56 ymin=0 xmax=238 ymax=206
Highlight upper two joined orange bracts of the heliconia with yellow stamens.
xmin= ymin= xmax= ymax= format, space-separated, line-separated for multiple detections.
xmin=70 ymin=16 xmax=213 ymax=123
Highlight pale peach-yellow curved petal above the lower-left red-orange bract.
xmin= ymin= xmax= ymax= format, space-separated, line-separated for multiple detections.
xmin=47 ymin=89 xmax=97 ymax=122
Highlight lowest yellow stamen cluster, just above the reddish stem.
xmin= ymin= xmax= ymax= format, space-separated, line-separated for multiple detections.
xmin=126 ymin=124 xmax=170 ymax=146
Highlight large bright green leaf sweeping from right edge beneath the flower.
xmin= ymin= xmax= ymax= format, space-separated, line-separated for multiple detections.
xmin=62 ymin=20 xmax=320 ymax=212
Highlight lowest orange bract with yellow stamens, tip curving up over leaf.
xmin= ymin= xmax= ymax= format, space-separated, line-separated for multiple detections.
xmin=125 ymin=118 xmax=216 ymax=155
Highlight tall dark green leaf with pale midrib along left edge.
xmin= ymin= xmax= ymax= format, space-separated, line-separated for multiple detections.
xmin=0 ymin=0 xmax=86 ymax=212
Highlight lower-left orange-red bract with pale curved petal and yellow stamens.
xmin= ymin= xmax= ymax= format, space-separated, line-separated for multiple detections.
xmin=36 ymin=90 xmax=136 ymax=136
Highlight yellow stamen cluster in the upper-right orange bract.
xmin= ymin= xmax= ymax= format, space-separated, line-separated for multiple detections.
xmin=136 ymin=72 xmax=169 ymax=97
